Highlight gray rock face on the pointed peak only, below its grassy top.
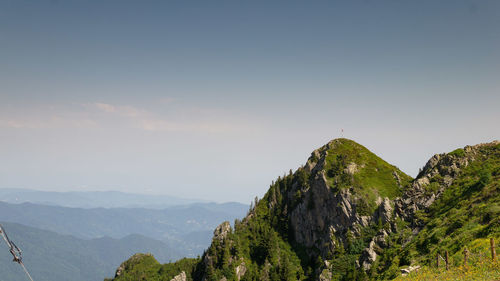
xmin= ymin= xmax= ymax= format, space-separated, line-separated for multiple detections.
xmin=288 ymin=142 xmax=401 ymax=262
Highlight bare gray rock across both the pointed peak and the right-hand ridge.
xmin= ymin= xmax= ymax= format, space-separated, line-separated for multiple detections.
xmin=288 ymin=140 xmax=492 ymax=270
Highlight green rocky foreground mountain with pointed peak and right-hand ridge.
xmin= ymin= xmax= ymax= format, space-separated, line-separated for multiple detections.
xmin=109 ymin=139 xmax=500 ymax=281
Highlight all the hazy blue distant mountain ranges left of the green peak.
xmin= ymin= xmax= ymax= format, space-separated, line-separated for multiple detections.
xmin=0 ymin=189 xmax=248 ymax=281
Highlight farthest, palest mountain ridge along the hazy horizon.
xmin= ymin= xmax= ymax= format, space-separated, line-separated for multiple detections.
xmin=0 ymin=188 xmax=207 ymax=209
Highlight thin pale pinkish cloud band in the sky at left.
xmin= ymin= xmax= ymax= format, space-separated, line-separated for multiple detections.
xmin=0 ymin=102 xmax=256 ymax=133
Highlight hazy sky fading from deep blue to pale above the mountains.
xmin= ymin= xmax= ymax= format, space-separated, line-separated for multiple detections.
xmin=0 ymin=0 xmax=500 ymax=203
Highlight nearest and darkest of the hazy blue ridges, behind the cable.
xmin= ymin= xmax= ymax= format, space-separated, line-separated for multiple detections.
xmin=0 ymin=222 xmax=180 ymax=281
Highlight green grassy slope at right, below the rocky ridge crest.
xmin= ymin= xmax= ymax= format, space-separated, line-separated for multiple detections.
xmin=379 ymin=141 xmax=500 ymax=280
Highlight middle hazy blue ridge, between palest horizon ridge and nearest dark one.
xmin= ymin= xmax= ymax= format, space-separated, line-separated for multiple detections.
xmin=0 ymin=202 xmax=248 ymax=256
